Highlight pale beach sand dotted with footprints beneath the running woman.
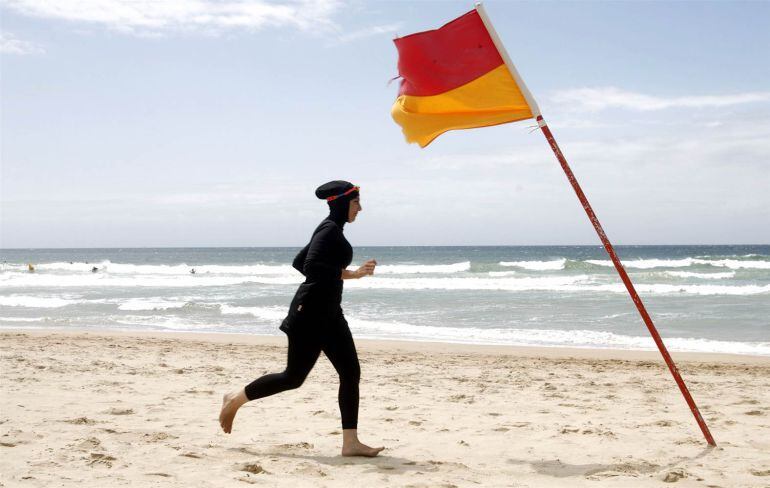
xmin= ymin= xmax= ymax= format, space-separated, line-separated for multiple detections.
xmin=0 ymin=330 xmax=770 ymax=488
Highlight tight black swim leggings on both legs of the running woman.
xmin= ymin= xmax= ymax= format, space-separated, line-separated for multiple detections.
xmin=246 ymin=321 xmax=361 ymax=429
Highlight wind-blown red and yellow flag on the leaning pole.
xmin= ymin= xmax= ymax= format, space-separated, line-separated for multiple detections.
xmin=391 ymin=10 xmax=537 ymax=147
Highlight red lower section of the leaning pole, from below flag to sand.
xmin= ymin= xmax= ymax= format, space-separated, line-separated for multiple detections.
xmin=537 ymin=115 xmax=717 ymax=446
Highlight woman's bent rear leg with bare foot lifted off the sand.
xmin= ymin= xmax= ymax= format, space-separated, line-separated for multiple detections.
xmin=219 ymin=333 xmax=321 ymax=434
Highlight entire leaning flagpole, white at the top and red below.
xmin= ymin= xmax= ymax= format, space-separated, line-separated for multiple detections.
xmin=476 ymin=3 xmax=716 ymax=446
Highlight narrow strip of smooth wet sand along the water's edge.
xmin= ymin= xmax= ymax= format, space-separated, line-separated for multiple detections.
xmin=0 ymin=328 xmax=770 ymax=365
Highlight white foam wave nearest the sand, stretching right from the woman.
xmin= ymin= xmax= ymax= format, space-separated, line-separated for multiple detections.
xmin=348 ymin=317 xmax=770 ymax=356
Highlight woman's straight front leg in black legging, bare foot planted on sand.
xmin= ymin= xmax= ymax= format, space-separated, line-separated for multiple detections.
xmin=323 ymin=319 xmax=384 ymax=457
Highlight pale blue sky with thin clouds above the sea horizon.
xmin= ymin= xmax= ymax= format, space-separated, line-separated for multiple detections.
xmin=0 ymin=0 xmax=770 ymax=248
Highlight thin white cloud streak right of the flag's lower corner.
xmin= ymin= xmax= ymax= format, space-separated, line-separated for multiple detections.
xmin=549 ymin=86 xmax=770 ymax=112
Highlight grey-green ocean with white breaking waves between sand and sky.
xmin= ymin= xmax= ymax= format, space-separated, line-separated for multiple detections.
xmin=0 ymin=245 xmax=770 ymax=356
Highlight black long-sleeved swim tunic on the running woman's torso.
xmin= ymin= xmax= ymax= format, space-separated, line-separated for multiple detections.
xmin=292 ymin=218 xmax=353 ymax=313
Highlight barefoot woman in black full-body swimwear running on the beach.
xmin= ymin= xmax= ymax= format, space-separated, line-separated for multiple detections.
xmin=219 ymin=181 xmax=384 ymax=457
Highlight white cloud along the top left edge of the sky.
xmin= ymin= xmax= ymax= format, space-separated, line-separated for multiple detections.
xmin=4 ymin=0 xmax=340 ymax=35
